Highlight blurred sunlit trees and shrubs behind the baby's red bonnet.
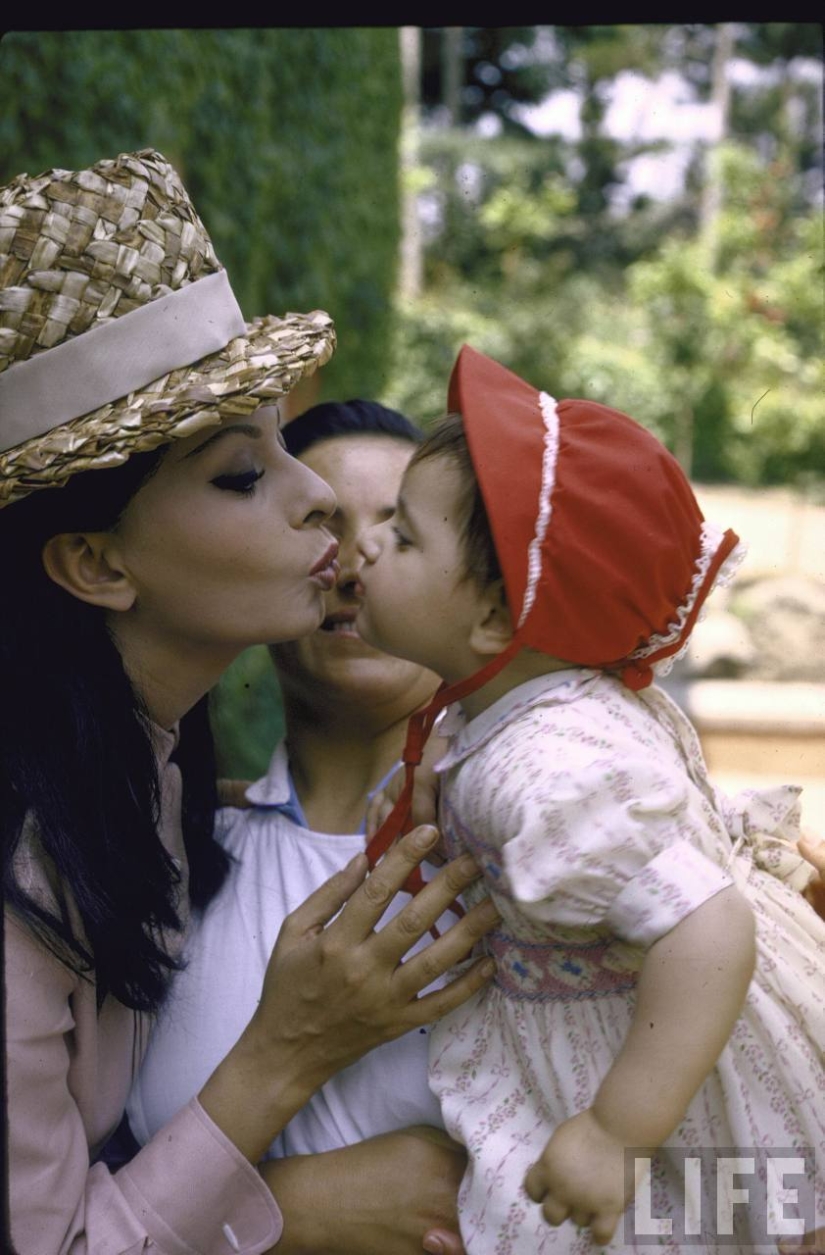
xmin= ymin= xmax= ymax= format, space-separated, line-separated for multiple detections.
xmin=388 ymin=23 xmax=825 ymax=484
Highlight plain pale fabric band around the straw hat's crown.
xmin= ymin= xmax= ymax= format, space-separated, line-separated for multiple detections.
xmin=0 ymin=270 xmax=246 ymax=452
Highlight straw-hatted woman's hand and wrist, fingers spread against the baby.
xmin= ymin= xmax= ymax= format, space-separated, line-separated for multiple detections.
xmin=198 ymin=828 xmax=499 ymax=1163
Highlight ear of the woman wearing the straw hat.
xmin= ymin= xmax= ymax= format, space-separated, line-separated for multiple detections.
xmin=43 ymin=532 xmax=136 ymax=611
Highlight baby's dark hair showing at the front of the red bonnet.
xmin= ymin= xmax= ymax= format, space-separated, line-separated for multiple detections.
xmin=409 ymin=414 xmax=501 ymax=589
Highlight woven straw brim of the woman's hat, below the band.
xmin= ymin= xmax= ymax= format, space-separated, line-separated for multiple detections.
xmin=0 ymin=310 xmax=335 ymax=508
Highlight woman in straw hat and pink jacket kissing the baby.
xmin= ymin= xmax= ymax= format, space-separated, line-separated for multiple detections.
xmin=0 ymin=151 xmax=490 ymax=1255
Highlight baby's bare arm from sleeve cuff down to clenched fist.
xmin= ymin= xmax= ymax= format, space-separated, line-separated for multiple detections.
xmin=526 ymin=886 xmax=755 ymax=1242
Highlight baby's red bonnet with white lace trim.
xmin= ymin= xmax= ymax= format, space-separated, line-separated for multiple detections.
xmin=448 ymin=345 xmax=745 ymax=689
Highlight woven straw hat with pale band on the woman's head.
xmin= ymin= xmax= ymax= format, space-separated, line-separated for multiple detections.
xmin=0 ymin=149 xmax=335 ymax=507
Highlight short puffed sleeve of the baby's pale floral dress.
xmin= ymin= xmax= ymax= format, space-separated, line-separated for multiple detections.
xmin=462 ymin=719 xmax=732 ymax=946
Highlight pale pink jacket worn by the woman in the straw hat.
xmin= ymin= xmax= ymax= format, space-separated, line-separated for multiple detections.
xmin=5 ymin=733 xmax=283 ymax=1255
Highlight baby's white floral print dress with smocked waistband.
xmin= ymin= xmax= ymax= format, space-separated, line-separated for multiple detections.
xmin=429 ymin=669 xmax=825 ymax=1255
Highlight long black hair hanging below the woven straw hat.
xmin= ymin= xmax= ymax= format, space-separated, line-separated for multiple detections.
xmin=0 ymin=449 xmax=227 ymax=1010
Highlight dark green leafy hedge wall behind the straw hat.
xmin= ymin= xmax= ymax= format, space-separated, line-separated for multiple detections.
xmin=0 ymin=28 xmax=402 ymax=395
